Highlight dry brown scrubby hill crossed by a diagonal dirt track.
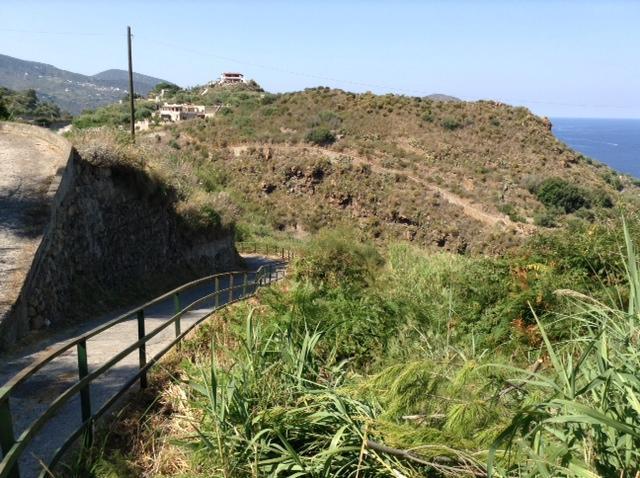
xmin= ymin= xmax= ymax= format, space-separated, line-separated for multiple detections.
xmin=125 ymin=88 xmax=638 ymax=253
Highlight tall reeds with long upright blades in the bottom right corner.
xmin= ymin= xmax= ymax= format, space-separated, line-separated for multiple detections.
xmin=490 ymin=224 xmax=640 ymax=477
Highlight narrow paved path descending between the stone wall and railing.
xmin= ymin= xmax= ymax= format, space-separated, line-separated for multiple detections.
xmin=0 ymin=256 xmax=284 ymax=478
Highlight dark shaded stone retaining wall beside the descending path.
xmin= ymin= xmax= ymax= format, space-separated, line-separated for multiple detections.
xmin=0 ymin=125 xmax=239 ymax=349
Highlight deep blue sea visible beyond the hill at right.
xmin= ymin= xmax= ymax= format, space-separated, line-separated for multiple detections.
xmin=551 ymin=118 xmax=640 ymax=178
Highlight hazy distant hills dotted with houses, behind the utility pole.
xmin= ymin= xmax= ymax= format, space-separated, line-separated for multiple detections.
xmin=0 ymin=55 xmax=172 ymax=114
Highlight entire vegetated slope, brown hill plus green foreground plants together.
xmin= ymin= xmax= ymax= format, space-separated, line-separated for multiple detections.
xmin=60 ymin=88 xmax=640 ymax=478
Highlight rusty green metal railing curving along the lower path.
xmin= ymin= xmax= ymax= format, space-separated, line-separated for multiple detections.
xmin=0 ymin=243 xmax=293 ymax=478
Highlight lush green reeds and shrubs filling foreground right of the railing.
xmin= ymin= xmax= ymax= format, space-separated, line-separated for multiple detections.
xmin=75 ymin=218 xmax=640 ymax=477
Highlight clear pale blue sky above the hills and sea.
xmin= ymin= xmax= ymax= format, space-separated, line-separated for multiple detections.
xmin=0 ymin=0 xmax=640 ymax=118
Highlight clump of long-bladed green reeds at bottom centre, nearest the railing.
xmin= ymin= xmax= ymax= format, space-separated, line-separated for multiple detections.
xmin=182 ymin=314 xmax=415 ymax=478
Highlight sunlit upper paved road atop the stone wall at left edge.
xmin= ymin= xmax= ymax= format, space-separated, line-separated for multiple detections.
xmin=0 ymin=122 xmax=70 ymax=340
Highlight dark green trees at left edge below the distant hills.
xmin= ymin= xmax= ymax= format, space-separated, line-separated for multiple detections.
xmin=0 ymin=87 xmax=69 ymax=126
